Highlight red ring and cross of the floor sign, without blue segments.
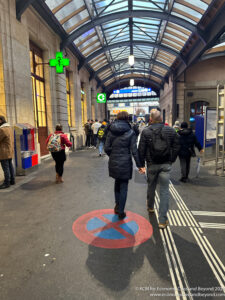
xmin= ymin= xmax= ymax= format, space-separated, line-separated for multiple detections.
xmin=72 ymin=209 xmax=153 ymax=249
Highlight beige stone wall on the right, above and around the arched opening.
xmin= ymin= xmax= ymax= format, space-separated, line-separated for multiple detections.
xmin=160 ymin=57 xmax=225 ymax=125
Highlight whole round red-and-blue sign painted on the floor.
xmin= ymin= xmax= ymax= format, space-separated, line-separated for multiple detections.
xmin=73 ymin=209 xmax=153 ymax=249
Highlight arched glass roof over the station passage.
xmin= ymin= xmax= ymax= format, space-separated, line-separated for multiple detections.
xmin=45 ymin=0 xmax=211 ymax=86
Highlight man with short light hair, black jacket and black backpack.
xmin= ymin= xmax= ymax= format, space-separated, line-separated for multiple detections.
xmin=138 ymin=109 xmax=180 ymax=229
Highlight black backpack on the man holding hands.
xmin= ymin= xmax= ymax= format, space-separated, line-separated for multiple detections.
xmin=149 ymin=126 xmax=171 ymax=164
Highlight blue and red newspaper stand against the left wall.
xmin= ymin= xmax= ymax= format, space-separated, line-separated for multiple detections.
xmin=14 ymin=123 xmax=38 ymax=175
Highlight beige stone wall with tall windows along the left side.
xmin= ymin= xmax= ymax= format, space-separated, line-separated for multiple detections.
xmin=0 ymin=0 xmax=105 ymax=180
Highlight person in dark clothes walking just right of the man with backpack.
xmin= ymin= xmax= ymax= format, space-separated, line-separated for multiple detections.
xmin=178 ymin=122 xmax=204 ymax=182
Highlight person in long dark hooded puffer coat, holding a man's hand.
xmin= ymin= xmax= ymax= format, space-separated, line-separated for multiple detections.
xmin=104 ymin=111 xmax=141 ymax=220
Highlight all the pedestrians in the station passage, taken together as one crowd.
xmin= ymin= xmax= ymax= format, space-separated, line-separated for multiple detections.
xmin=0 ymin=109 xmax=203 ymax=229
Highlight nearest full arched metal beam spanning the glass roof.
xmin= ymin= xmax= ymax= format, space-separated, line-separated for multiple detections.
xmin=61 ymin=10 xmax=205 ymax=49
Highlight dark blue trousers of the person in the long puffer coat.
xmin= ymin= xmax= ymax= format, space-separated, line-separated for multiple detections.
xmin=114 ymin=179 xmax=128 ymax=214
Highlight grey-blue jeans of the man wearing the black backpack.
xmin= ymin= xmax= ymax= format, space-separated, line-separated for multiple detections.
xmin=147 ymin=164 xmax=171 ymax=223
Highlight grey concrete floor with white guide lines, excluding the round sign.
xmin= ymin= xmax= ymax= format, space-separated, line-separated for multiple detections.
xmin=0 ymin=150 xmax=225 ymax=300
